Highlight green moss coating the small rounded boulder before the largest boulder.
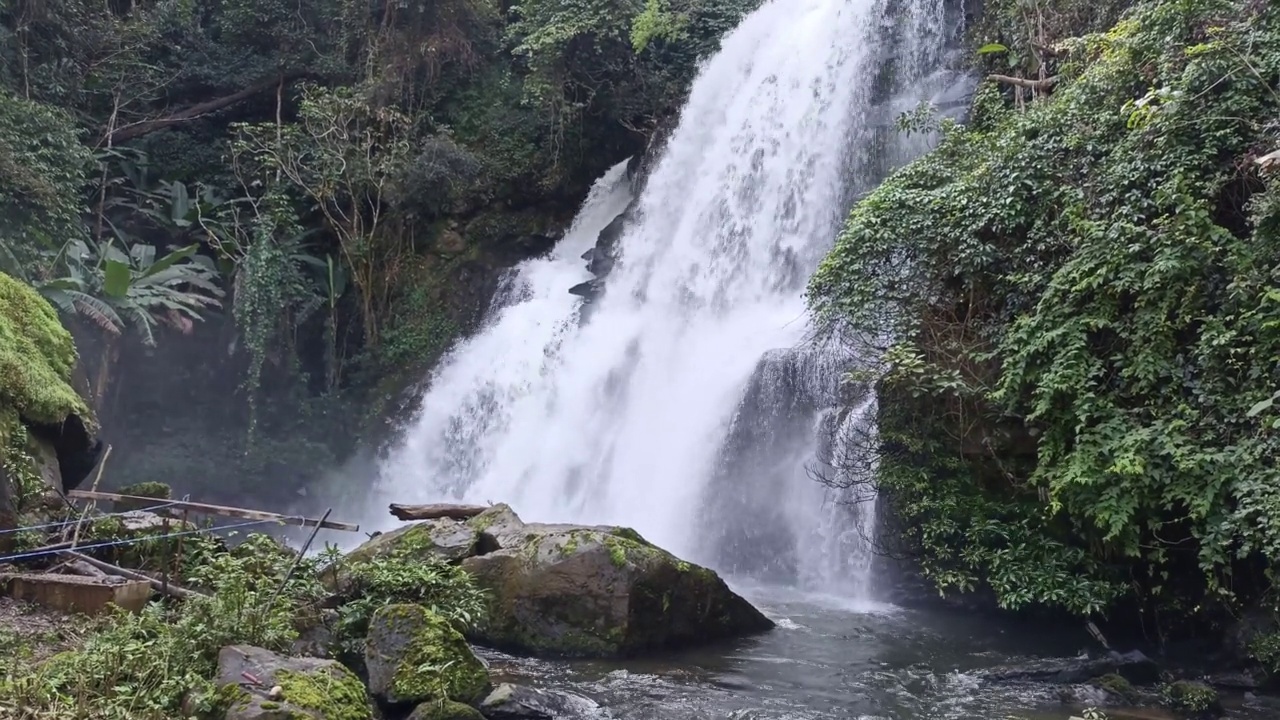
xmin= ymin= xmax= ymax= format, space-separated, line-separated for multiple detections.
xmin=372 ymin=605 xmax=489 ymax=702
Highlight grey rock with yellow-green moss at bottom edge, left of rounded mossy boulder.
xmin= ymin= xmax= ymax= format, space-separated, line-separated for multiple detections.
xmin=218 ymin=644 xmax=374 ymax=720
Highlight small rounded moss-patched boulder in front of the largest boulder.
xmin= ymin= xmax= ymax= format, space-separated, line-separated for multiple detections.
xmin=365 ymin=605 xmax=489 ymax=705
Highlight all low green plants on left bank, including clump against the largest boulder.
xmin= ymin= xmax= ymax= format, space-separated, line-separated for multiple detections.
xmin=0 ymin=523 xmax=485 ymax=720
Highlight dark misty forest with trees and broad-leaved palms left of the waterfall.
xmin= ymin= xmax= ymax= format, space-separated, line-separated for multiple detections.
xmin=0 ymin=0 xmax=754 ymax=504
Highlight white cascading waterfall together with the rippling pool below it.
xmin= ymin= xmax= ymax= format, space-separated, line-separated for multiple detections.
xmin=332 ymin=0 xmax=1280 ymax=720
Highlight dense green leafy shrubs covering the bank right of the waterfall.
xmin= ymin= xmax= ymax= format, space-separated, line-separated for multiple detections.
xmin=810 ymin=0 xmax=1280 ymax=655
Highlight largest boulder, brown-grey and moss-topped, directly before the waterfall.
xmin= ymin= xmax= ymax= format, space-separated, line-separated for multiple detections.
xmin=462 ymin=505 xmax=773 ymax=657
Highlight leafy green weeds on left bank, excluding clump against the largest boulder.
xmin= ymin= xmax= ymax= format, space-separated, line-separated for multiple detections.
xmin=0 ymin=536 xmax=321 ymax=720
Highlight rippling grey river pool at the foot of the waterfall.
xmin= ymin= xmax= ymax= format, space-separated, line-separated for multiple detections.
xmin=484 ymin=587 xmax=1280 ymax=720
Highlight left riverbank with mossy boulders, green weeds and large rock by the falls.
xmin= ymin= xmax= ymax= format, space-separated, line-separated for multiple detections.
xmin=0 ymin=491 xmax=773 ymax=720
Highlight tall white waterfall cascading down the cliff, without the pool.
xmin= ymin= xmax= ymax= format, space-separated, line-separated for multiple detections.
xmin=371 ymin=0 xmax=959 ymax=594
